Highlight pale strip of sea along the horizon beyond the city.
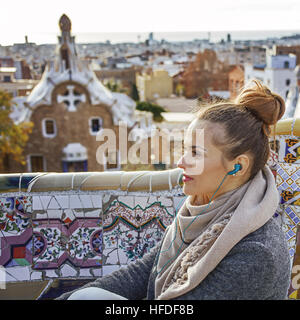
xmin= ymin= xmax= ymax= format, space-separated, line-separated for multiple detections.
xmin=8 ymin=29 xmax=300 ymax=45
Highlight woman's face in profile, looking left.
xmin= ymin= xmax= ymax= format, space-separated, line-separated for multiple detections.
xmin=177 ymin=120 xmax=235 ymax=204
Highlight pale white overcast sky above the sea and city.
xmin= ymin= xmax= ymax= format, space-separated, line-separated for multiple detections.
xmin=0 ymin=0 xmax=300 ymax=45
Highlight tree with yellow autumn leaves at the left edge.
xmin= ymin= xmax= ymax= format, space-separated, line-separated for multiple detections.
xmin=0 ymin=90 xmax=33 ymax=172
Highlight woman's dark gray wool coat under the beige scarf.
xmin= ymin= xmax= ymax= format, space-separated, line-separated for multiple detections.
xmin=57 ymin=218 xmax=291 ymax=300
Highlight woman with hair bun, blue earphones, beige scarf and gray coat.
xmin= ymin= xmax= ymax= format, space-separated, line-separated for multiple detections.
xmin=58 ymin=80 xmax=290 ymax=300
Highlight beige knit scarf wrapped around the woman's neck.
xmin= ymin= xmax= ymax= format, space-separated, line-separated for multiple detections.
xmin=155 ymin=165 xmax=279 ymax=300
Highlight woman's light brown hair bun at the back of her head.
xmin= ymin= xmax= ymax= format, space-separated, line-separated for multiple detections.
xmin=235 ymin=80 xmax=285 ymax=126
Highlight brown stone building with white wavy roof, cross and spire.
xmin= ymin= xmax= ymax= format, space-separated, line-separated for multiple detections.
xmin=9 ymin=14 xmax=152 ymax=172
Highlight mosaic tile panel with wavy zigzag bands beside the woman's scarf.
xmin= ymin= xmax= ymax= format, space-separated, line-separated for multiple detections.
xmin=103 ymin=196 xmax=174 ymax=265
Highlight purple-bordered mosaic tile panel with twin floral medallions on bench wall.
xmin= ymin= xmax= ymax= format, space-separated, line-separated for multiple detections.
xmin=33 ymin=218 xmax=102 ymax=270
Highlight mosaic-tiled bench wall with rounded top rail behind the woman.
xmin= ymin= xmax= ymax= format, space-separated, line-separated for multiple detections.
xmin=0 ymin=118 xmax=300 ymax=300
